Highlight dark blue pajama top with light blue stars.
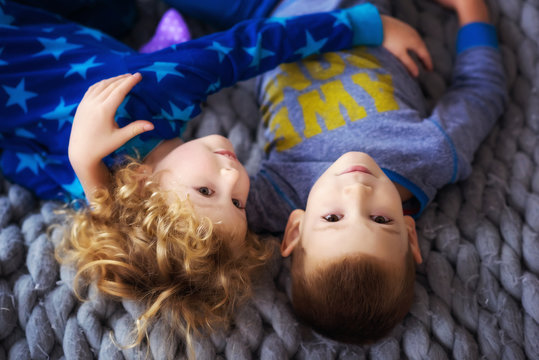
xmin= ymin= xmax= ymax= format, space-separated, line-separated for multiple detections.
xmin=0 ymin=0 xmax=382 ymax=200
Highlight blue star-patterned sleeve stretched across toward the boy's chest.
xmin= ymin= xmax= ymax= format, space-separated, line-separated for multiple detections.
xmin=123 ymin=4 xmax=382 ymax=138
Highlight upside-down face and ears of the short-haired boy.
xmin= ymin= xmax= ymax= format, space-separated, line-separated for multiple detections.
xmin=282 ymin=152 xmax=421 ymax=271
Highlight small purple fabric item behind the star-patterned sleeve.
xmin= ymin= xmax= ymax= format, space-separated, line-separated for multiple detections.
xmin=139 ymin=8 xmax=191 ymax=53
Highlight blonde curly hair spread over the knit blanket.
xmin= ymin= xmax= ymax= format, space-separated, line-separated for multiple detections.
xmin=57 ymin=159 xmax=273 ymax=357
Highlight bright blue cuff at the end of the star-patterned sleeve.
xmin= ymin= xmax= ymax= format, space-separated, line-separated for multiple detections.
xmin=343 ymin=3 xmax=384 ymax=46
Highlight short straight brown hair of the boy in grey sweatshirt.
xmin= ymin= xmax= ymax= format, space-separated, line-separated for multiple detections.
xmin=291 ymin=246 xmax=415 ymax=345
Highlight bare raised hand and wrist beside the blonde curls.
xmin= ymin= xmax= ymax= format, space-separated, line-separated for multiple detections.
xmin=68 ymin=74 xmax=153 ymax=201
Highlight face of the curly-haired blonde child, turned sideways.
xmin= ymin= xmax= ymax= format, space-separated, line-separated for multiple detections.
xmin=148 ymin=135 xmax=249 ymax=253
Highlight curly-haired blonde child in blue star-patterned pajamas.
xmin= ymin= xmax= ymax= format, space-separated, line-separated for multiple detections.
xmin=0 ymin=1 xmax=388 ymax=354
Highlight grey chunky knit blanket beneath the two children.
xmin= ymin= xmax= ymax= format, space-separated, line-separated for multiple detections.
xmin=0 ymin=0 xmax=539 ymax=360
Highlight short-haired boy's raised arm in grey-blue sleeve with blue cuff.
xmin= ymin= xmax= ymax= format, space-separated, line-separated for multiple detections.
xmin=429 ymin=0 xmax=507 ymax=181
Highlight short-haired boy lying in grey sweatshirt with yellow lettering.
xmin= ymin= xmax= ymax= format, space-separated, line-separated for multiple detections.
xmin=248 ymin=0 xmax=506 ymax=344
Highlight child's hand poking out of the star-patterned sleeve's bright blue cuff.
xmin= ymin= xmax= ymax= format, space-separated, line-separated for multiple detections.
xmin=381 ymin=15 xmax=432 ymax=77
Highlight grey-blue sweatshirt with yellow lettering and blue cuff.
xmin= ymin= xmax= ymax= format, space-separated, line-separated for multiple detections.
xmin=247 ymin=16 xmax=507 ymax=233
